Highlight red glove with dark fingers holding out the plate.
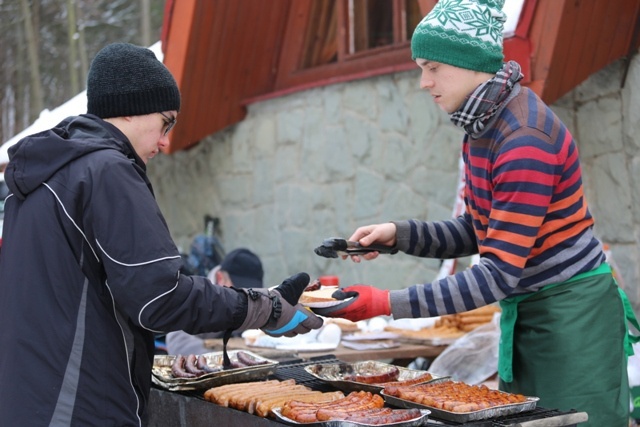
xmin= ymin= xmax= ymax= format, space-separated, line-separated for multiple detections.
xmin=313 ymin=285 xmax=391 ymax=322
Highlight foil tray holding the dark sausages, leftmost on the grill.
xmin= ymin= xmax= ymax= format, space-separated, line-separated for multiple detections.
xmin=151 ymin=350 xmax=279 ymax=391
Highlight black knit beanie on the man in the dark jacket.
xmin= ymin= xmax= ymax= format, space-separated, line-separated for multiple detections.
xmin=87 ymin=43 xmax=180 ymax=119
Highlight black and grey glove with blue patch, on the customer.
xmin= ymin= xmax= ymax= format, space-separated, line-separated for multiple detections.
xmin=239 ymin=273 xmax=323 ymax=337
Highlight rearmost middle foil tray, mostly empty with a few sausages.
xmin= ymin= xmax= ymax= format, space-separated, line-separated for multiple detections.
xmin=304 ymin=360 xmax=450 ymax=393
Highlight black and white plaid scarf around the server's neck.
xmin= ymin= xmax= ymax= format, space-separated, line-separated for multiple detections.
xmin=449 ymin=61 xmax=524 ymax=135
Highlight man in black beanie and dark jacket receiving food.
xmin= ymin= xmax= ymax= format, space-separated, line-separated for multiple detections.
xmin=0 ymin=43 xmax=322 ymax=426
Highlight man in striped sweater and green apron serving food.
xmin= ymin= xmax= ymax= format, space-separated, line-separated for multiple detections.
xmin=322 ymin=0 xmax=633 ymax=427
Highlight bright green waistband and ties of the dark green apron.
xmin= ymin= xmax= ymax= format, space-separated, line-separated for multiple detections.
xmin=498 ymin=262 xmax=612 ymax=383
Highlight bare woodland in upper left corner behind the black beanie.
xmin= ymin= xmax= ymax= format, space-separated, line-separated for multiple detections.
xmin=0 ymin=0 xmax=165 ymax=144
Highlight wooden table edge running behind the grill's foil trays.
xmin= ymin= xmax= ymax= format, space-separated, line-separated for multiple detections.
xmin=205 ymin=338 xmax=447 ymax=364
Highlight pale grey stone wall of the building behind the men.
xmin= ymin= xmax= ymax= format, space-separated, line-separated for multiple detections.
xmin=149 ymin=57 xmax=640 ymax=307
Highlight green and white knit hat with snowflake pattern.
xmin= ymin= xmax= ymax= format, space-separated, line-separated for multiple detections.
xmin=411 ymin=0 xmax=507 ymax=74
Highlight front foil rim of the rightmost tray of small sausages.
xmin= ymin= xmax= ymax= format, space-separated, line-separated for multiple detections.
xmin=380 ymin=390 xmax=540 ymax=423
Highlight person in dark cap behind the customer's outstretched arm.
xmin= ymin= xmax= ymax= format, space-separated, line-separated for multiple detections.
xmin=165 ymin=248 xmax=264 ymax=355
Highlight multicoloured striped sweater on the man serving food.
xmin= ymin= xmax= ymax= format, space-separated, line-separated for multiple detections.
xmin=391 ymin=85 xmax=605 ymax=318
